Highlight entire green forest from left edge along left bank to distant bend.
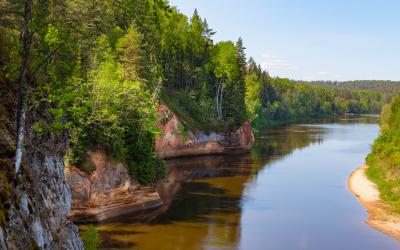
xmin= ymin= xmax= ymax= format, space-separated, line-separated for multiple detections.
xmin=0 ymin=0 xmax=397 ymax=184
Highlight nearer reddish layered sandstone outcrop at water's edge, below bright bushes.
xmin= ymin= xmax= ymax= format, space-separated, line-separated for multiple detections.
xmin=66 ymin=151 xmax=162 ymax=222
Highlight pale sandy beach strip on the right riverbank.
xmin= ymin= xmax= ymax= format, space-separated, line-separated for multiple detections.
xmin=348 ymin=165 xmax=400 ymax=240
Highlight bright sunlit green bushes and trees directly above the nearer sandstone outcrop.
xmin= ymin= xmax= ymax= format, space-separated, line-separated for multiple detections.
xmin=63 ymin=28 xmax=163 ymax=184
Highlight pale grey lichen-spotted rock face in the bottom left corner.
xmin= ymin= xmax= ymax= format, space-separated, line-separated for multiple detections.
xmin=0 ymin=140 xmax=83 ymax=250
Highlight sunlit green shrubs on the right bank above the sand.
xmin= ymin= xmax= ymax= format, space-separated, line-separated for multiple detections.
xmin=367 ymin=95 xmax=400 ymax=212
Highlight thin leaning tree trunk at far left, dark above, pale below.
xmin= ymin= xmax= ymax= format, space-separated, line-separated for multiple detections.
xmin=15 ymin=0 xmax=32 ymax=173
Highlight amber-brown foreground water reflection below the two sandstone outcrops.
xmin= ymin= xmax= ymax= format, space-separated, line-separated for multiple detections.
xmin=99 ymin=155 xmax=247 ymax=249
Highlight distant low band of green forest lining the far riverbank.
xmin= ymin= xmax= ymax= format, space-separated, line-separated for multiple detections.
xmin=245 ymin=59 xmax=386 ymax=127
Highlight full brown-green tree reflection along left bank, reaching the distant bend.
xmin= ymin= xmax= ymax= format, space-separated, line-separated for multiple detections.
xmin=97 ymin=118 xmax=376 ymax=249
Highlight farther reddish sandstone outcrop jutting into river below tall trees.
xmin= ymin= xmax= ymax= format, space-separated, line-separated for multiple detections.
xmin=155 ymin=104 xmax=254 ymax=159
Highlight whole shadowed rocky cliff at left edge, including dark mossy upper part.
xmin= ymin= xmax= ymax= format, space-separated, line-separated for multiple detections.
xmin=0 ymin=83 xmax=83 ymax=250
